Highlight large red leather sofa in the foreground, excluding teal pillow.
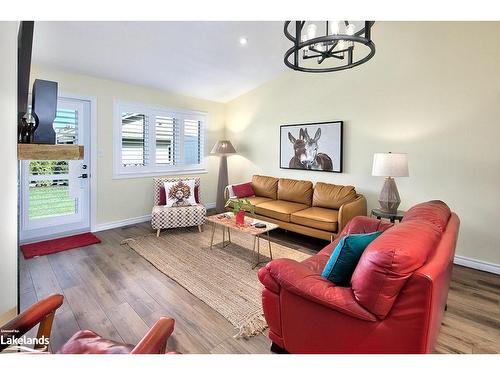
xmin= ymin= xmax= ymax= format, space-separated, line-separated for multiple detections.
xmin=259 ymin=201 xmax=460 ymax=353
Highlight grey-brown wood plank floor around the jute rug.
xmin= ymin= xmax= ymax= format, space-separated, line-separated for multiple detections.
xmin=19 ymin=223 xmax=500 ymax=353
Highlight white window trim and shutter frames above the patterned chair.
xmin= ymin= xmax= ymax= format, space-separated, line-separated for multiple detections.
xmin=113 ymin=99 xmax=208 ymax=179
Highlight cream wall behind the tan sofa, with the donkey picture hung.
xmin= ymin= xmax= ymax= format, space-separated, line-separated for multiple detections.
xmin=226 ymin=22 xmax=500 ymax=264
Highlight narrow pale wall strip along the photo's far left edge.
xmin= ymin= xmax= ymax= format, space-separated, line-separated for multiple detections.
xmin=0 ymin=22 xmax=18 ymax=324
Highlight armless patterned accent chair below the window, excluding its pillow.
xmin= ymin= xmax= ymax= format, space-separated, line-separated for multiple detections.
xmin=151 ymin=177 xmax=207 ymax=237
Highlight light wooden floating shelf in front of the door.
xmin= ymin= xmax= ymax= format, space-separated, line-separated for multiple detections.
xmin=17 ymin=143 xmax=83 ymax=160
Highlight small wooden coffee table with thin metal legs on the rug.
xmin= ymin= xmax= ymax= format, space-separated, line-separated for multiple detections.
xmin=207 ymin=212 xmax=279 ymax=269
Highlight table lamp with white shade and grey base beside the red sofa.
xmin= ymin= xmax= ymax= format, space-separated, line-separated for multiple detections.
xmin=372 ymin=152 xmax=409 ymax=213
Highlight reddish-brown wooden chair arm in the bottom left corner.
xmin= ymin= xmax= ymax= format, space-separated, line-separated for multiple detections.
xmin=0 ymin=294 xmax=64 ymax=351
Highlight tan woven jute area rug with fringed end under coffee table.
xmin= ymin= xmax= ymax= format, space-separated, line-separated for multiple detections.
xmin=122 ymin=224 xmax=310 ymax=337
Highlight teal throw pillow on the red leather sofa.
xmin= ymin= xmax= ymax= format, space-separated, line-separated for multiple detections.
xmin=321 ymin=232 xmax=382 ymax=286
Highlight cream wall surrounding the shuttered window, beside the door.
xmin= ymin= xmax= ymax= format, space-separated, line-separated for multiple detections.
xmin=31 ymin=66 xmax=224 ymax=225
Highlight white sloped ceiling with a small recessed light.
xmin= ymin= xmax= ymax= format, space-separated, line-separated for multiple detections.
xmin=33 ymin=21 xmax=290 ymax=102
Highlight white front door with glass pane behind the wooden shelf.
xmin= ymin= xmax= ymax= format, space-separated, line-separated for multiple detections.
xmin=20 ymin=98 xmax=91 ymax=243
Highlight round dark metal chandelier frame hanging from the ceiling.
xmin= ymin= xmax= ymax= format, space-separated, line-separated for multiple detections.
xmin=284 ymin=21 xmax=375 ymax=73
